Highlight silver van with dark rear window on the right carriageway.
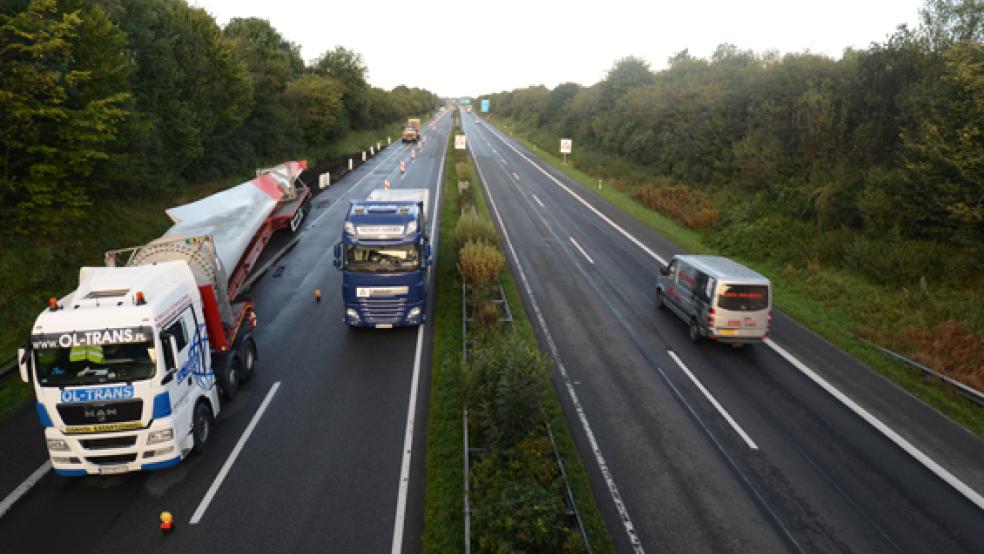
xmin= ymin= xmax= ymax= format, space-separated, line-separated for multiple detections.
xmin=656 ymin=256 xmax=772 ymax=346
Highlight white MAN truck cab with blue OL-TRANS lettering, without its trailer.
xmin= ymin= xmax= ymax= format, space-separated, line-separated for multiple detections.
xmin=18 ymin=261 xmax=250 ymax=476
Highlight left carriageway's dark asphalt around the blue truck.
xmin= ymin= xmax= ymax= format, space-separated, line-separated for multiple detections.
xmin=0 ymin=110 xmax=451 ymax=553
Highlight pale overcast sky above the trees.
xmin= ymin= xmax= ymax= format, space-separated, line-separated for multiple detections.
xmin=189 ymin=0 xmax=923 ymax=96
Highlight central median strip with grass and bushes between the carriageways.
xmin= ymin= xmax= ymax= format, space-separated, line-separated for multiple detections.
xmin=424 ymin=114 xmax=612 ymax=552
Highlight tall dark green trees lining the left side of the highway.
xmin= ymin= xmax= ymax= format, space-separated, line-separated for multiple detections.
xmin=0 ymin=0 xmax=439 ymax=235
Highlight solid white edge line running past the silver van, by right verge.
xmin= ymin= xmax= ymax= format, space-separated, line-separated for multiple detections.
xmin=484 ymin=119 xmax=984 ymax=509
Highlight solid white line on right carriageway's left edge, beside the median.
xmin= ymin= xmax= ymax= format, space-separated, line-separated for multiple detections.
xmin=475 ymin=153 xmax=644 ymax=554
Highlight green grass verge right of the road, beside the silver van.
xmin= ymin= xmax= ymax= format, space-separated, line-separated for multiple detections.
xmin=489 ymin=117 xmax=984 ymax=437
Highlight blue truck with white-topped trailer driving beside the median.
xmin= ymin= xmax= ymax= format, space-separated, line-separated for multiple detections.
xmin=335 ymin=189 xmax=432 ymax=328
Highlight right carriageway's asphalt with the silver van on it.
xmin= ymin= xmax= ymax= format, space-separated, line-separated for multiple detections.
xmin=464 ymin=110 xmax=984 ymax=552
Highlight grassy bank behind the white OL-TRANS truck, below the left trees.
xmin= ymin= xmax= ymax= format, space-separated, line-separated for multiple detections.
xmin=0 ymin=124 xmax=400 ymax=421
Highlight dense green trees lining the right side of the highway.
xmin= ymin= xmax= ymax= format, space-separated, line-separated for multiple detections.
xmin=484 ymin=0 xmax=984 ymax=253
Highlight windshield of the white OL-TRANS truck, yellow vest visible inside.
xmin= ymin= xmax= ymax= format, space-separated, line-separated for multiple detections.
xmin=34 ymin=342 xmax=157 ymax=387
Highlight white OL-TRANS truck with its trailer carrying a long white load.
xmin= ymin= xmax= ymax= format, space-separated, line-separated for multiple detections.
xmin=17 ymin=162 xmax=308 ymax=476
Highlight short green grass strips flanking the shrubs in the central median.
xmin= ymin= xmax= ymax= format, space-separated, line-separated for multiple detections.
xmin=424 ymin=122 xmax=614 ymax=553
